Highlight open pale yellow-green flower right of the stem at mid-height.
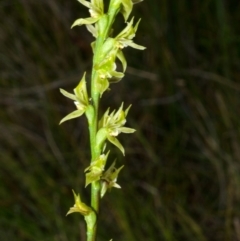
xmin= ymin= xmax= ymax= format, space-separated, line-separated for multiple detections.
xmin=97 ymin=104 xmax=136 ymax=155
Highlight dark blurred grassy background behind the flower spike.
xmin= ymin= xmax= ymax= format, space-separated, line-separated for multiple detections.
xmin=0 ymin=0 xmax=240 ymax=241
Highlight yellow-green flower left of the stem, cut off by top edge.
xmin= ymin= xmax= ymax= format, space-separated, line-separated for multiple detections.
xmin=71 ymin=0 xmax=104 ymax=27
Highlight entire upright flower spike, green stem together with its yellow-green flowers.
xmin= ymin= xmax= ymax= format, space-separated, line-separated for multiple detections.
xmin=60 ymin=0 xmax=145 ymax=241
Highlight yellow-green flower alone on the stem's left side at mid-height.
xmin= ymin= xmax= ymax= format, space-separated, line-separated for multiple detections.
xmin=60 ymin=73 xmax=90 ymax=124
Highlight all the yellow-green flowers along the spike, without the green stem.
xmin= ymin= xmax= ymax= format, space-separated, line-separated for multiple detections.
xmin=60 ymin=0 xmax=145 ymax=216
